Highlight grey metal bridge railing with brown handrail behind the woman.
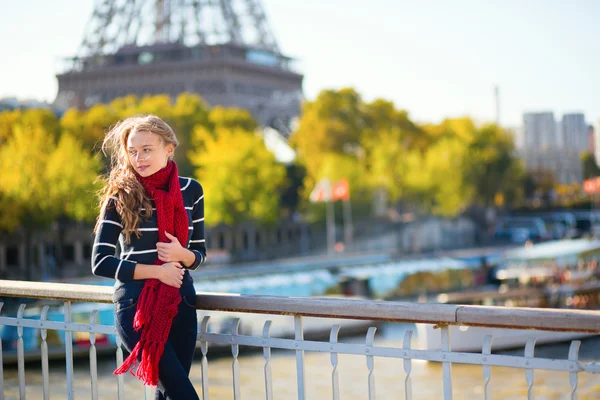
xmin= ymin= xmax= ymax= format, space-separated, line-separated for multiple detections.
xmin=0 ymin=281 xmax=600 ymax=400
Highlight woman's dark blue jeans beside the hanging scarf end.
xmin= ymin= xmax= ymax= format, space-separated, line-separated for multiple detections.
xmin=115 ymin=295 xmax=198 ymax=400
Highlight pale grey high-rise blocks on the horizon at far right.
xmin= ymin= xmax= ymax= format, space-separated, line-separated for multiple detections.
xmin=516 ymin=112 xmax=588 ymax=183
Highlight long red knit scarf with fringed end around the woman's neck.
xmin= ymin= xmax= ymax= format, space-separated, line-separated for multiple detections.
xmin=114 ymin=160 xmax=188 ymax=386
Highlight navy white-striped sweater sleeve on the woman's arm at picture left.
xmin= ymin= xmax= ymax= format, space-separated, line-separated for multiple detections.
xmin=92 ymin=197 xmax=137 ymax=282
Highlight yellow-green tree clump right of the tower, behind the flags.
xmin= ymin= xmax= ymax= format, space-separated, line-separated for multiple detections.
xmin=290 ymin=89 xmax=523 ymax=216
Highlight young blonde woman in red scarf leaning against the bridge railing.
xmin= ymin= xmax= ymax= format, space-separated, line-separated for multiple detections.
xmin=92 ymin=115 xmax=206 ymax=400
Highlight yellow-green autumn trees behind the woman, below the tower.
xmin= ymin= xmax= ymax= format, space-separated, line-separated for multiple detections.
xmin=0 ymin=93 xmax=274 ymax=230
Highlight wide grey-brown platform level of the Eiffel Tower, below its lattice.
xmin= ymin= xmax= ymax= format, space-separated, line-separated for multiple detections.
xmin=55 ymin=43 xmax=303 ymax=127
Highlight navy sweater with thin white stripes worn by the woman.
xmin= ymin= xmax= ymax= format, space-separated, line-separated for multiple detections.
xmin=92 ymin=177 xmax=206 ymax=297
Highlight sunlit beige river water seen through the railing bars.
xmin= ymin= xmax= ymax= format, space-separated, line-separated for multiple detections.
xmin=4 ymin=324 xmax=600 ymax=400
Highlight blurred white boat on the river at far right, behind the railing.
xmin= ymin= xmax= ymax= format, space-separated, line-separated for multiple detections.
xmin=417 ymin=239 xmax=600 ymax=352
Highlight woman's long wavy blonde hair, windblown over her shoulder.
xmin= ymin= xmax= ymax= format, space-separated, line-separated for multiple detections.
xmin=94 ymin=115 xmax=179 ymax=243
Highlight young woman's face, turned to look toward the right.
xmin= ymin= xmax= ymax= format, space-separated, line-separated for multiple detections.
xmin=126 ymin=131 xmax=175 ymax=177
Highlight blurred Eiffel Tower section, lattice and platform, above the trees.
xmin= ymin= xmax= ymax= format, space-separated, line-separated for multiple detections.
xmin=55 ymin=0 xmax=303 ymax=132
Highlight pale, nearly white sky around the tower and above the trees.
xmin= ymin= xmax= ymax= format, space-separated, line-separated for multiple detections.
xmin=0 ymin=0 xmax=600 ymax=126
